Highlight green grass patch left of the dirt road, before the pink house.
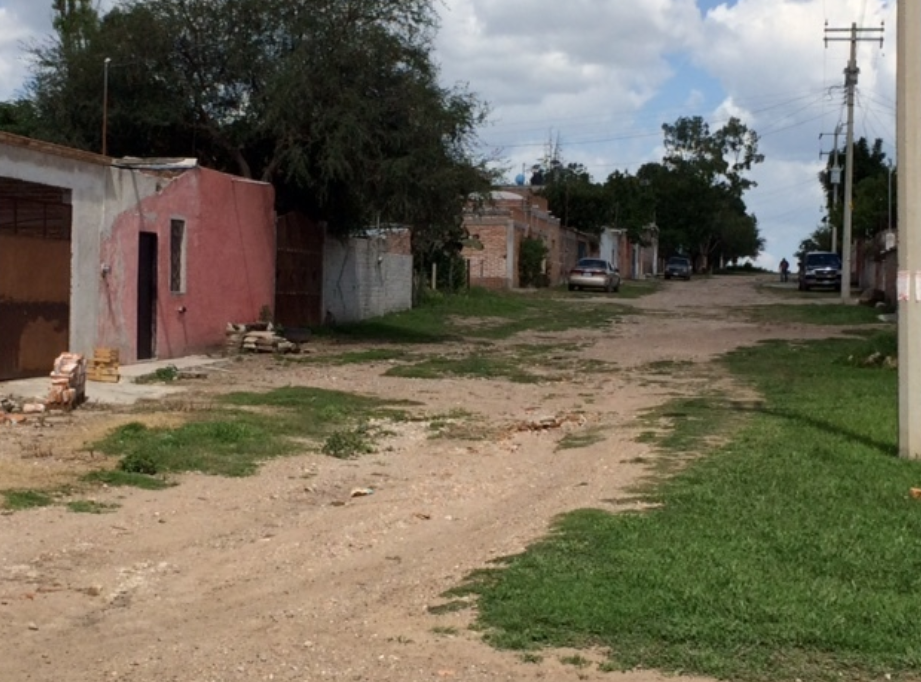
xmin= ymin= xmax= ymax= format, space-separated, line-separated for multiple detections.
xmin=92 ymin=387 xmax=412 ymax=481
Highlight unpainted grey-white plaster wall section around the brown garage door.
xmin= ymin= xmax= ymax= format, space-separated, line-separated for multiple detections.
xmin=0 ymin=140 xmax=164 ymax=354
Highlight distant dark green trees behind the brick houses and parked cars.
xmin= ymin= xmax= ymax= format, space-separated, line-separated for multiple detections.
xmin=532 ymin=117 xmax=764 ymax=267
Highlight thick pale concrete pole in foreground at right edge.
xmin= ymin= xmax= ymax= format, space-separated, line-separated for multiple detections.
xmin=896 ymin=0 xmax=921 ymax=459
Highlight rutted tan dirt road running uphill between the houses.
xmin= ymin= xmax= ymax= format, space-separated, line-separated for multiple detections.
xmin=0 ymin=278 xmax=840 ymax=682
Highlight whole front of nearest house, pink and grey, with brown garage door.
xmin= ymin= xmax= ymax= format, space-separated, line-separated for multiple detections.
xmin=0 ymin=133 xmax=275 ymax=379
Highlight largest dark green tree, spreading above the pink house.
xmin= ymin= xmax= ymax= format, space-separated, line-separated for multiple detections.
xmin=23 ymin=0 xmax=490 ymax=243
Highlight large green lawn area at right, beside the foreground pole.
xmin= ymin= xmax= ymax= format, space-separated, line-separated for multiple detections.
xmin=452 ymin=330 xmax=921 ymax=681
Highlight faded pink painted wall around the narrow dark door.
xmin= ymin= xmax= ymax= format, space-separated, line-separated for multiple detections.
xmin=97 ymin=168 xmax=275 ymax=363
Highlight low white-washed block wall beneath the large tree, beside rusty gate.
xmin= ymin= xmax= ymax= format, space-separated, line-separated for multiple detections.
xmin=323 ymin=237 xmax=413 ymax=323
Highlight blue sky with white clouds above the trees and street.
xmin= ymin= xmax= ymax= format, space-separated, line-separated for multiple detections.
xmin=0 ymin=0 xmax=896 ymax=267
